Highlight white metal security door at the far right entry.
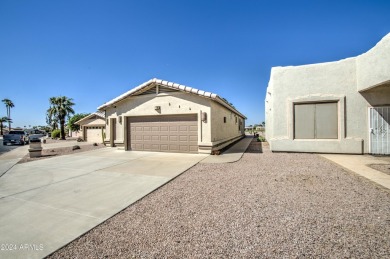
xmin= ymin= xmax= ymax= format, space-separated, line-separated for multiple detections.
xmin=369 ymin=107 xmax=390 ymax=155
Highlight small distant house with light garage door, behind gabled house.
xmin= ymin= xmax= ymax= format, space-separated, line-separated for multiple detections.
xmin=72 ymin=112 xmax=106 ymax=143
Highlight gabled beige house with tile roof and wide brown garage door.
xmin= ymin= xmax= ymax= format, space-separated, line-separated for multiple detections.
xmin=98 ymin=79 xmax=246 ymax=153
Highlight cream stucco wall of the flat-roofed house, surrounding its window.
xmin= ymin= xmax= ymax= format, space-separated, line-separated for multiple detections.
xmin=265 ymin=34 xmax=390 ymax=154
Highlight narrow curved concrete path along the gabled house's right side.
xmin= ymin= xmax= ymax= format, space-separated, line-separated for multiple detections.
xmin=200 ymin=136 xmax=253 ymax=164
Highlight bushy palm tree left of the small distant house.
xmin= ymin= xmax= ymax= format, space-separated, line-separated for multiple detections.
xmin=47 ymin=96 xmax=74 ymax=139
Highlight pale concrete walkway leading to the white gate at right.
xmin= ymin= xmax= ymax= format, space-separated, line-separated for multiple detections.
xmin=320 ymin=154 xmax=390 ymax=189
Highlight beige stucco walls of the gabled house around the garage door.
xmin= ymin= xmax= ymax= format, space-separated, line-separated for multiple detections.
xmin=102 ymin=92 xmax=245 ymax=153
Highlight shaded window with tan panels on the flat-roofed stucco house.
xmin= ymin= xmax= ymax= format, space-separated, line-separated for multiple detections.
xmin=294 ymin=102 xmax=338 ymax=139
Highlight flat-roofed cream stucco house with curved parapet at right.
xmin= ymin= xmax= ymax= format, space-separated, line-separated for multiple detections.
xmin=265 ymin=34 xmax=390 ymax=154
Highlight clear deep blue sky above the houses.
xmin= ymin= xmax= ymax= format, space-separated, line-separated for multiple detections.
xmin=0 ymin=0 xmax=390 ymax=127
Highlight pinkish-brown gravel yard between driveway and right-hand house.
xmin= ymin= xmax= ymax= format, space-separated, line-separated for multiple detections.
xmin=48 ymin=142 xmax=390 ymax=258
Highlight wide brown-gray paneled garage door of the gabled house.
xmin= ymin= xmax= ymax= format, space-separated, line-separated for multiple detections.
xmin=127 ymin=114 xmax=198 ymax=153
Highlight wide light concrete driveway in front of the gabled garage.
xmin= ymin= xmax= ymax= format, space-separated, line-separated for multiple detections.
xmin=0 ymin=148 xmax=207 ymax=258
